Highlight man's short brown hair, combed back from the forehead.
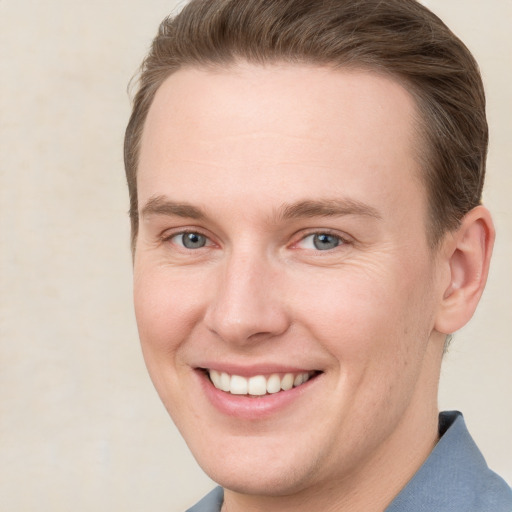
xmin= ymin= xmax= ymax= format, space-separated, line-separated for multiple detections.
xmin=124 ymin=0 xmax=488 ymax=247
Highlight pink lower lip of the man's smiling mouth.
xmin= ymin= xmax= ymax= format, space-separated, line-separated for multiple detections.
xmin=197 ymin=370 xmax=320 ymax=420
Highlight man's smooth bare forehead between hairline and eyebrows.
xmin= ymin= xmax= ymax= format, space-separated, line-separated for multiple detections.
xmin=138 ymin=64 xmax=424 ymax=230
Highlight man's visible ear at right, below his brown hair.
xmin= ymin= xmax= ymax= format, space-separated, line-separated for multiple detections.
xmin=435 ymin=206 xmax=495 ymax=334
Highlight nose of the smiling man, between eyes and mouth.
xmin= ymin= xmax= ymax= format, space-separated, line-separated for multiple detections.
xmin=204 ymin=248 xmax=290 ymax=345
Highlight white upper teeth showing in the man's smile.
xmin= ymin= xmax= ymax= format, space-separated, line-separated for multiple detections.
xmin=208 ymin=370 xmax=311 ymax=395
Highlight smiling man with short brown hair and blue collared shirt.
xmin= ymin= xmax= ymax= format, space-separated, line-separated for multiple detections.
xmin=125 ymin=0 xmax=512 ymax=512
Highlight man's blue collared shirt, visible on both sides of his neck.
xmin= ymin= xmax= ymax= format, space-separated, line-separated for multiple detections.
xmin=187 ymin=411 xmax=512 ymax=512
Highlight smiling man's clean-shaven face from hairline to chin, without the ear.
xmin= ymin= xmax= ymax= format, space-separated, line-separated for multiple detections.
xmin=134 ymin=64 xmax=442 ymax=495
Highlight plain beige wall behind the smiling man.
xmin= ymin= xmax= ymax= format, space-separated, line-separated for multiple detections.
xmin=0 ymin=0 xmax=512 ymax=512
